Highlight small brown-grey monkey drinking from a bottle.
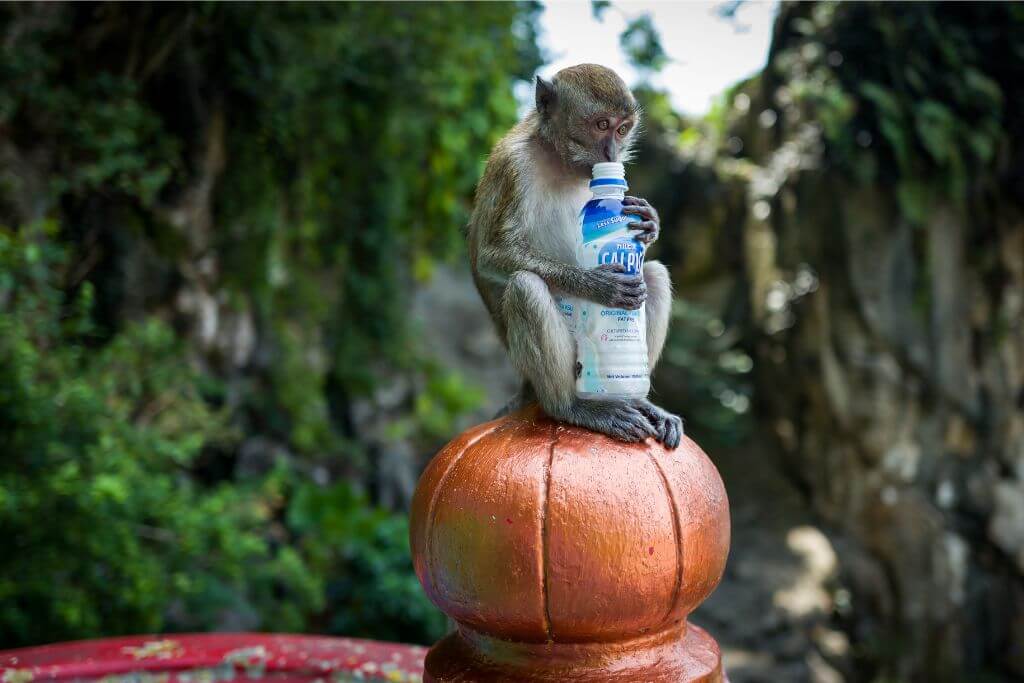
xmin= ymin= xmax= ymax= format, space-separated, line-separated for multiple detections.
xmin=467 ymin=65 xmax=683 ymax=449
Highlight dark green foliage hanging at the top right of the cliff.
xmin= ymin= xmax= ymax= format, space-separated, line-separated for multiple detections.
xmin=768 ymin=3 xmax=1024 ymax=223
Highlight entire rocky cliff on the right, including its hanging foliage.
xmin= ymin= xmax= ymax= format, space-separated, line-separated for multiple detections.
xmin=638 ymin=5 xmax=1024 ymax=681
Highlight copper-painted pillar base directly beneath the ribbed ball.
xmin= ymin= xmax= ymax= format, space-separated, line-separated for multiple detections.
xmin=423 ymin=622 xmax=727 ymax=683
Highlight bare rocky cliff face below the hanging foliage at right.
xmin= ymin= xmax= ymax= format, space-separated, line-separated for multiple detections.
xmin=744 ymin=158 xmax=1024 ymax=675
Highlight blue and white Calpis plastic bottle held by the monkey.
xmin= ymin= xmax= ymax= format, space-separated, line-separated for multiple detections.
xmin=572 ymin=163 xmax=650 ymax=398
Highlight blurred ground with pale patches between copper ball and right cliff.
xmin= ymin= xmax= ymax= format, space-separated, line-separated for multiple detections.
xmin=691 ymin=440 xmax=849 ymax=683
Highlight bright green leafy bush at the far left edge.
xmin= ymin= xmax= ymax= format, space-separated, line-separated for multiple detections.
xmin=0 ymin=226 xmax=253 ymax=644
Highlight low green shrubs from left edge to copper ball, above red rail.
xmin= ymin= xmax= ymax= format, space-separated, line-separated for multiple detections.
xmin=0 ymin=226 xmax=444 ymax=644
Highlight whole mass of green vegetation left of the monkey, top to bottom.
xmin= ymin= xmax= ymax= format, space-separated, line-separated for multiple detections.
xmin=0 ymin=3 xmax=540 ymax=645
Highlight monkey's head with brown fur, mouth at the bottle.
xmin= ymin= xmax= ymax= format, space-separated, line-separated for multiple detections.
xmin=537 ymin=65 xmax=640 ymax=175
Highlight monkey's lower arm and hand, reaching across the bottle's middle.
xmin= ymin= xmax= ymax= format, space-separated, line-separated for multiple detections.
xmin=476 ymin=226 xmax=647 ymax=309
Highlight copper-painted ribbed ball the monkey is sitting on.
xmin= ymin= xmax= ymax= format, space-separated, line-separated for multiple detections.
xmin=411 ymin=407 xmax=729 ymax=679
